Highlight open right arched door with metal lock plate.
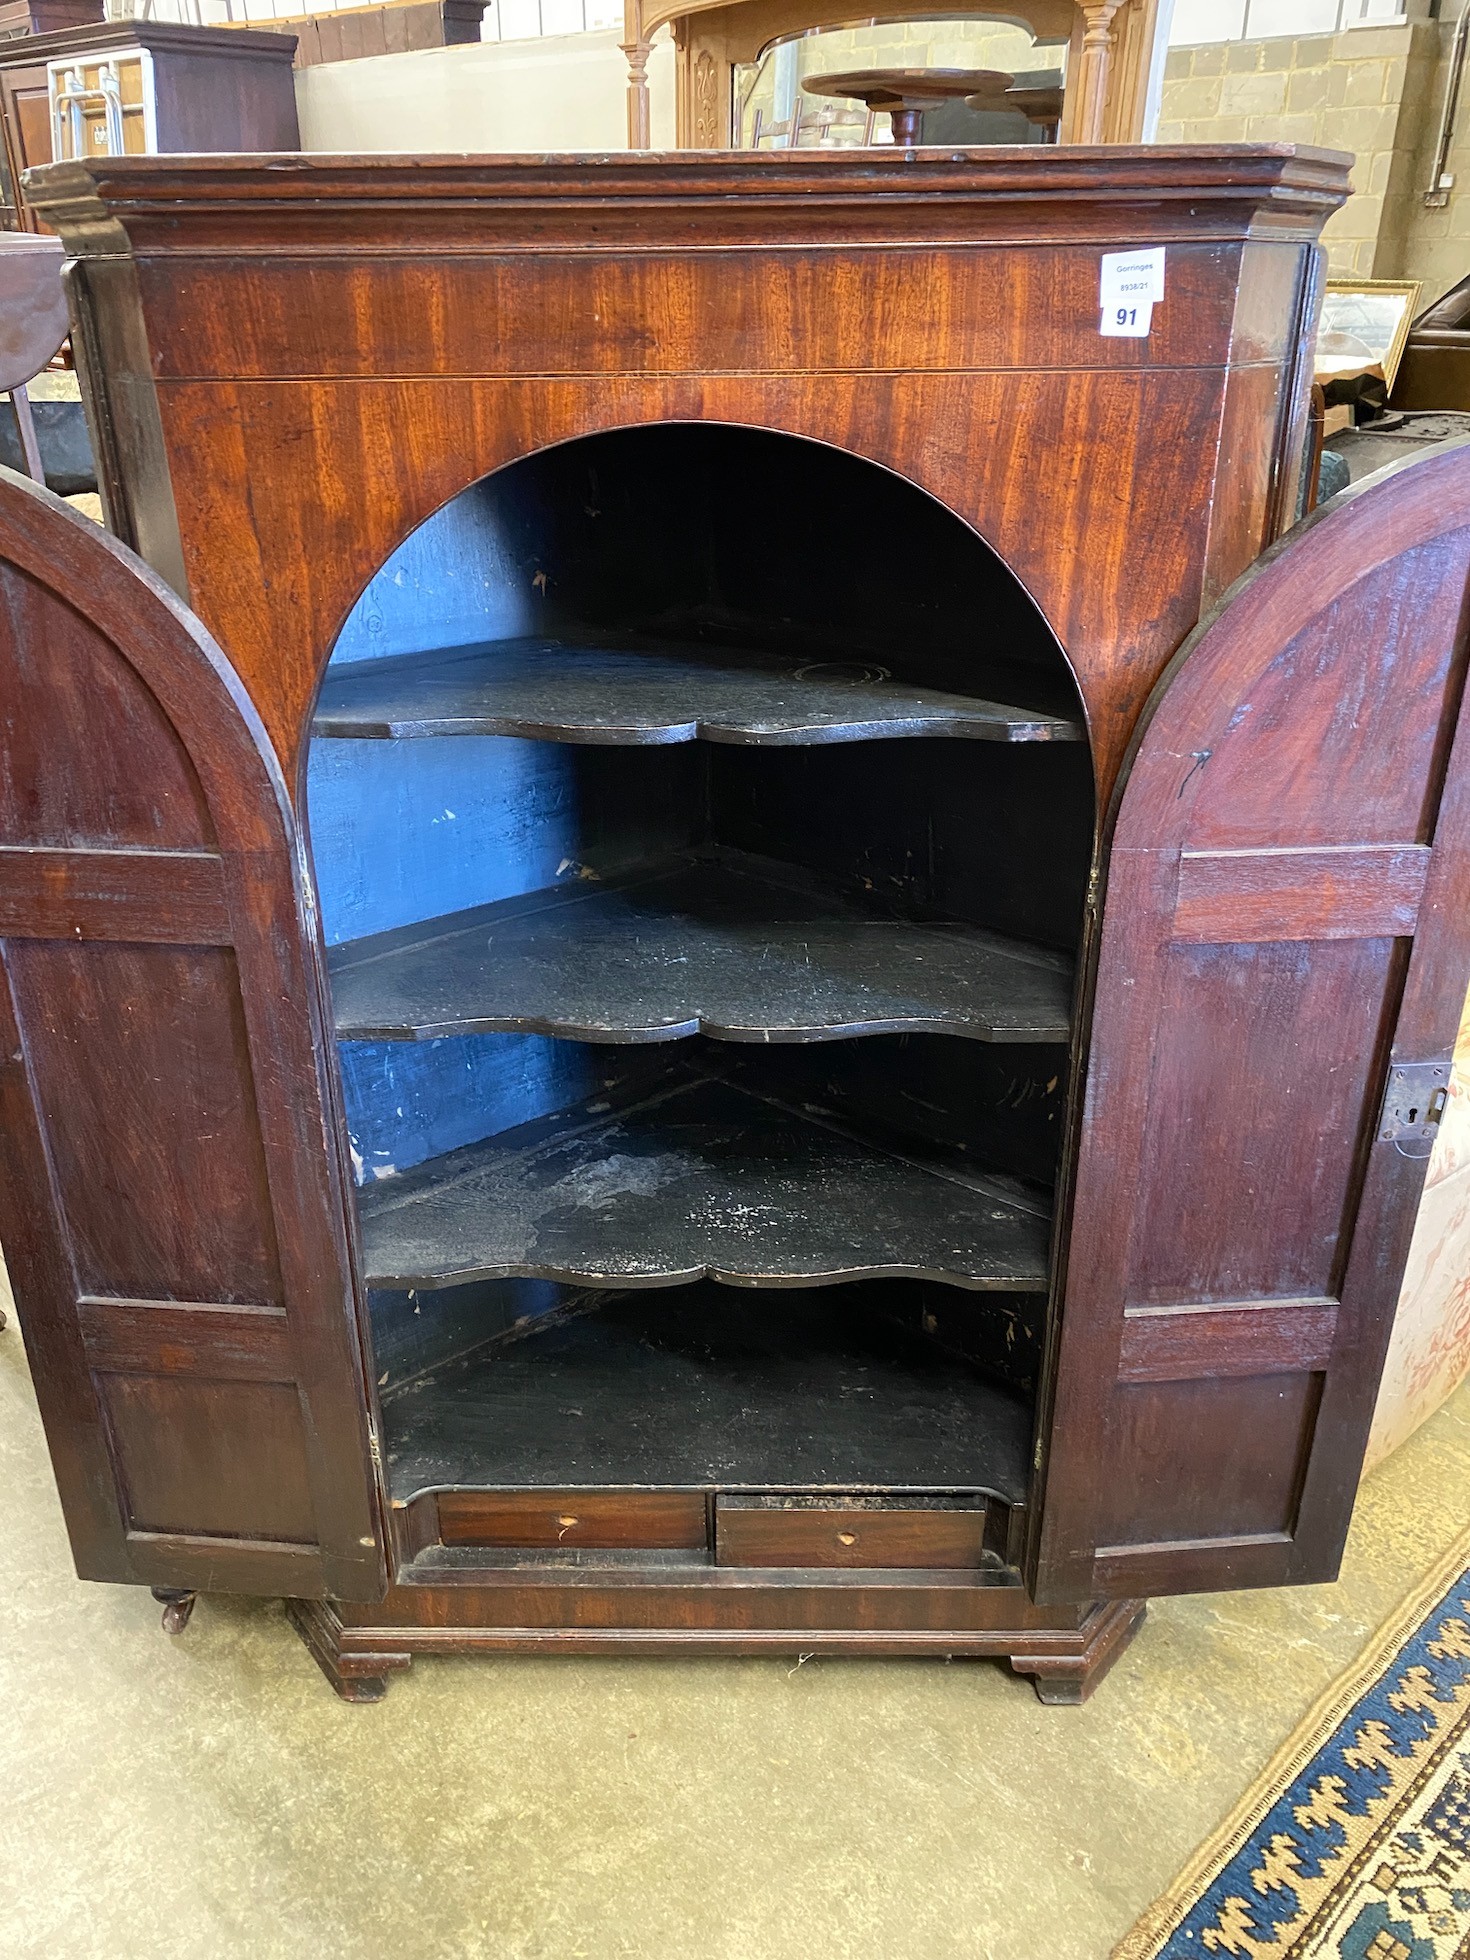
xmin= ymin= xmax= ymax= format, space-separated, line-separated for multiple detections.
xmin=1031 ymin=445 xmax=1470 ymax=1599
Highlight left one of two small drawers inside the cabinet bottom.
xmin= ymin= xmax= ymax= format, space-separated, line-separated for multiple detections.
xmin=439 ymin=1490 xmax=710 ymax=1552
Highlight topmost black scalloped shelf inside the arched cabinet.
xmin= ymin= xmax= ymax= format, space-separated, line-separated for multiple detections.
xmin=312 ymin=639 xmax=1084 ymax=745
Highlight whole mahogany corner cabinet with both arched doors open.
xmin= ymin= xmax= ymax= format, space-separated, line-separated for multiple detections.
xmin=0 ymin=147 xmax=1470 ymax=1701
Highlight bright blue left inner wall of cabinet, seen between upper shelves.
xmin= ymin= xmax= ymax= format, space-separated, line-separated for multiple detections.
xmin=306 ymin=482 xmax=590 ymax=1182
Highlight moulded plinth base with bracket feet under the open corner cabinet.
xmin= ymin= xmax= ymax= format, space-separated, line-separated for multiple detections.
xmin=286 ymin=1574 xmax=1145 ymax=1703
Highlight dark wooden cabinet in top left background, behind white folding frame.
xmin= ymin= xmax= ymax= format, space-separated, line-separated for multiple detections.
xmin=0 ymin=10 xmax=300 ymax=231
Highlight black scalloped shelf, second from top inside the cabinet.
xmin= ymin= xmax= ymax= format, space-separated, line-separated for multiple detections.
xmin=331 ymin=853 xmax=1072 ymax=1043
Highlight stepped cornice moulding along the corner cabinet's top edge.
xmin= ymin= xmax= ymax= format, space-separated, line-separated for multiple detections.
xmin=25 ymin=143 xmax=1352 ymax=257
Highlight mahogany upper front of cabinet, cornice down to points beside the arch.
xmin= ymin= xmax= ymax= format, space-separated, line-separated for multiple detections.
xmin=31 ymin=145 xmax=1348 ymax=803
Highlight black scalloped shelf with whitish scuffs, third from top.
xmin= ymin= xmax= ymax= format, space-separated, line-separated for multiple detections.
xmin=359 ymin=1074 xmax=1049 ymax=1292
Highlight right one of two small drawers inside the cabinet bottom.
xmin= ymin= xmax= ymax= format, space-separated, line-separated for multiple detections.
xmin=715 ymin=1497 xmax=986 ymax=1570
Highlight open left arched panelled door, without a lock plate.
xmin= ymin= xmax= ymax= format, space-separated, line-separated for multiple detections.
xmin=0 ymin=470 xmax=384 ymax=1599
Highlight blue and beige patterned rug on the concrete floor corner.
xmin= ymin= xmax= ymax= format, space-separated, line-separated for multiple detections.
xmin=1113 ymin=1537 xmax=1470 ymax=1960
